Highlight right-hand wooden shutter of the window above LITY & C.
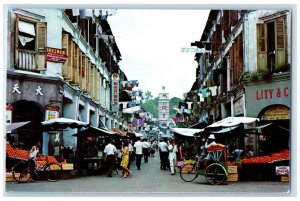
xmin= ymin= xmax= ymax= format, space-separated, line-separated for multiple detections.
xmin=275 ymin=17 xmax=286 ymax=68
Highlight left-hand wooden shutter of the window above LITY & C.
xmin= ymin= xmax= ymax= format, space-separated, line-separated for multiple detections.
xmin=256 ymin=24 xmax=267 ymax=70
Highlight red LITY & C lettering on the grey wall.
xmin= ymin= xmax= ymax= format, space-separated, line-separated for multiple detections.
xmin=256 ymin=87 xmax=289 ymax=101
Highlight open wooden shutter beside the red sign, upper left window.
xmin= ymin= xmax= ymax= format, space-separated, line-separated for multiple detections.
xmin=36 ymin=22 xmax=47 ymax=71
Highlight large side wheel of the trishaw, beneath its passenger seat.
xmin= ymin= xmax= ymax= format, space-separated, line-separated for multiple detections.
xmin=205 ymin=163 xmax=227 ymax=185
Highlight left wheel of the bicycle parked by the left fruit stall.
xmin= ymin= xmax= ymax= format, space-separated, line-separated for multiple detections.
xmin=12 ymin=161 xmax=31 ymax=183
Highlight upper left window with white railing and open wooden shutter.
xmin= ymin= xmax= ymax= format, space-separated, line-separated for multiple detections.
xmin=15 ymin=15 xmax=47 ymax=71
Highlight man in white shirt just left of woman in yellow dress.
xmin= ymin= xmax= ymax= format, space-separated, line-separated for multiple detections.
xmin=104 ymin=138 xmax=117 ymax=177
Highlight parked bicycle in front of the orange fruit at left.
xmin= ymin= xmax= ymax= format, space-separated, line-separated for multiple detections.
xmin=12 ymin=157 xmax=62 ymax=183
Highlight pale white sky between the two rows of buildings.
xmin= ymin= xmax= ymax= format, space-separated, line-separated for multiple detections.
xmin=108 ymin=9 xmax=209 ymax=98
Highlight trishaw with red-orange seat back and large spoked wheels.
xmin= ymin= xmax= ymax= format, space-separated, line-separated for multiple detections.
xmin=180 ymin=144 xmax=228 ymax=185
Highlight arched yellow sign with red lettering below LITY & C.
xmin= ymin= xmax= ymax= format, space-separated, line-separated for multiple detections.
xmin=260 ymin=106 xmax=290 ymax=120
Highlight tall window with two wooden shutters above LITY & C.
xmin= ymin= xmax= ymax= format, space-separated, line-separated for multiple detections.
xmin=256 ymin=17 xmax=287 ymax=72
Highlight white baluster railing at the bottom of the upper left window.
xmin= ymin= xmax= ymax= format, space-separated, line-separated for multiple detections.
xmin=18 ymin=50 xmax=36 ymax=70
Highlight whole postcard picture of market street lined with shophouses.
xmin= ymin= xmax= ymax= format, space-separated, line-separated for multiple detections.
xmin=3 ymin=6 xmax=296 ymax=196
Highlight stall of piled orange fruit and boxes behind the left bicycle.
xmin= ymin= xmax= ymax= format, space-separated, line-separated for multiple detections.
xmin=6 ymin=143 xmax=74 ymax=181
